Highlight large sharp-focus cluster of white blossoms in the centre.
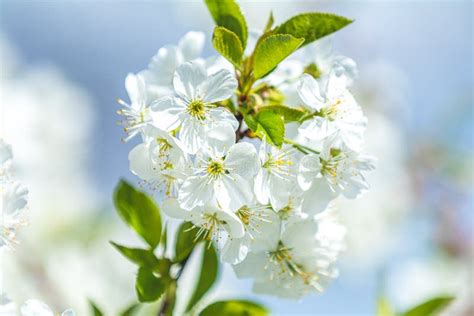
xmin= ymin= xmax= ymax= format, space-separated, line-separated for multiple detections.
xmin=119 ymin=32 xmax=374 ymax=298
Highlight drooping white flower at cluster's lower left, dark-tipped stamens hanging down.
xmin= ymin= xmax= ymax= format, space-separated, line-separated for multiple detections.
xmin=161 ymin=198 xmax=244 ymax=241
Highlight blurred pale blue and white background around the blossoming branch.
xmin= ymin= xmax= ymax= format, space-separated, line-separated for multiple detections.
xmin=0 ymin=0 xmax=474 ymax=315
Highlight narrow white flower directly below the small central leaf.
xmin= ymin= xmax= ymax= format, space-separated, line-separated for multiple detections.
xmin=254 ymin=139 xmax=296 ymax=210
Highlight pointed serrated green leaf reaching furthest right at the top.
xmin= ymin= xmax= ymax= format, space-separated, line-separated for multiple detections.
xmin=275 ymin=13 xmax=352 ymax=46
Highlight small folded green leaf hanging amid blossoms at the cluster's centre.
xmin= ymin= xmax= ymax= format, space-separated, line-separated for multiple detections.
xmin=255 ymin=111 xmax=285 ymax=147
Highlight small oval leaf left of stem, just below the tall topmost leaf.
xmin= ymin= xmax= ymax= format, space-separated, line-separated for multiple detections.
xmin=212 ymin=26 xmax=244 ymax=69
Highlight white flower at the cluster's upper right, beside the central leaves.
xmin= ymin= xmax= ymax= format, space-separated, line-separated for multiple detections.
xmin=298 ymin=73 xmax=367 ymax=150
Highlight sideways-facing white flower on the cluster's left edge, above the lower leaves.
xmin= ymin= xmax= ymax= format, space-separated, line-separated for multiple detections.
xmin=128 ymin=126 xmax=189 ymax=196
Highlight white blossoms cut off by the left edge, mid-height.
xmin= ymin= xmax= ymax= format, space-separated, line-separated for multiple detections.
xmin=0 ymin=139 xmax=28 ymax=249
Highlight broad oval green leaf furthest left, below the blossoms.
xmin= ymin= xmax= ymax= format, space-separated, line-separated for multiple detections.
xmin=114 ymin=180 xmax=161 ymax=249
